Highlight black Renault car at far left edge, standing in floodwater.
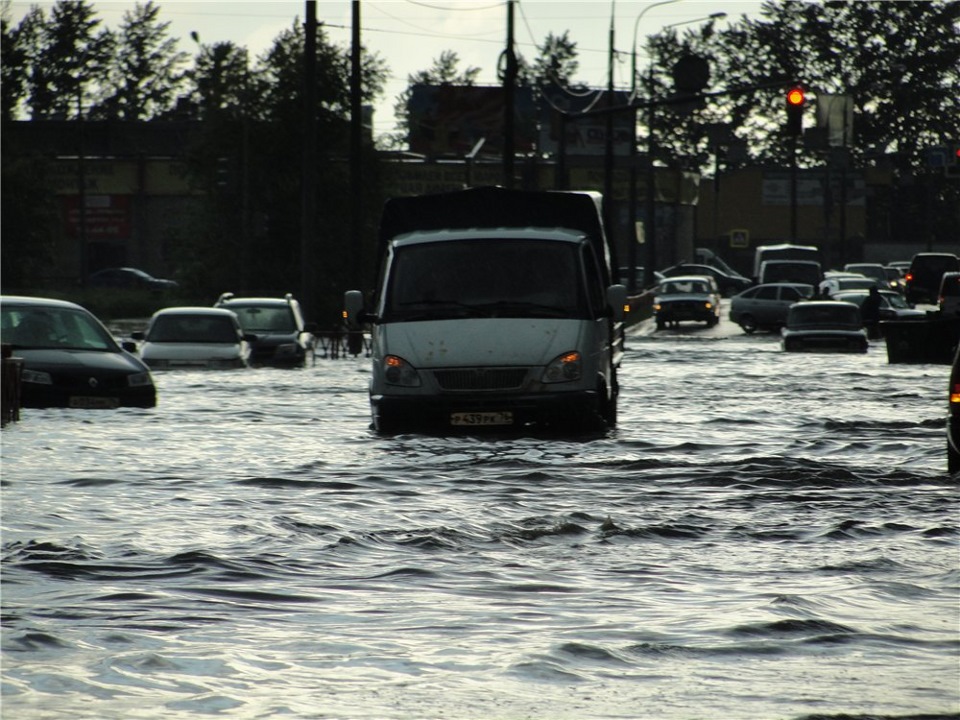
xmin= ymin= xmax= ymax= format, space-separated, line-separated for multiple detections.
xmin=0 ymin=295 xmax=157 ymax=409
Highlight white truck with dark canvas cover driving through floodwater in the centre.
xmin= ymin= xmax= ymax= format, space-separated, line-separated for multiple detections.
xmin=344 ymin=187 xmax=627 ymax=432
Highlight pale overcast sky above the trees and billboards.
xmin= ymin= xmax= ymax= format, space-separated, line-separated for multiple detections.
xmin=5 ymin=0 xmax=761 ymax=135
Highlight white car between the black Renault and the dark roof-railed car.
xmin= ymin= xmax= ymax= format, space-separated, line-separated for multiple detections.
xmin=131 ymin=307 xmax=256 ymax=369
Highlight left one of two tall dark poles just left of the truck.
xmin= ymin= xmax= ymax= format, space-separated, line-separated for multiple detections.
xmin=300 ymin=0 xmax=317 ymax=317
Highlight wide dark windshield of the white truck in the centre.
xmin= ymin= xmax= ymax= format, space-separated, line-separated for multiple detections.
xmin=383 ymin=238 xmax=589 ymax=322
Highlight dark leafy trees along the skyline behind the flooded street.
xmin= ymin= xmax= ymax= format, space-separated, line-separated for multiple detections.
xmin=0 ymin=0 xmax=960 ymax=320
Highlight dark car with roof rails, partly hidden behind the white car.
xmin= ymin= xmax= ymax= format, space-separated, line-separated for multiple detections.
xmin=215 ymin=293 xmax=317 ymax=367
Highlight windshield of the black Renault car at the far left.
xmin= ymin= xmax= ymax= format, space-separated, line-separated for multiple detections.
xmin=2 ymin=306 xmax=120 ymax=352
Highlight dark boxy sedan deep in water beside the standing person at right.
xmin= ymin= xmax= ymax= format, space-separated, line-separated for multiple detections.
xmin=780 ymin=300 xmax=869 ymax=352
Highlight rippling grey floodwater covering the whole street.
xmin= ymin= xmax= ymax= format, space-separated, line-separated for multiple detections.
xmin=2 ymin=320 xmax=960 ymax=720
